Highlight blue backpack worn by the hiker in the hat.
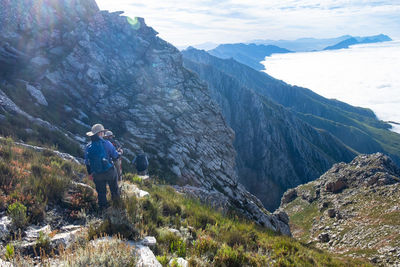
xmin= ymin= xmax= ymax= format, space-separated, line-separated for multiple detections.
xmin=87 ymin=140 xmax=113 ymax=173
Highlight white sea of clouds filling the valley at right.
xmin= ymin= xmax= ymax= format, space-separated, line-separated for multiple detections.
xmin=262 ymin=41 xmax=400 ymax=133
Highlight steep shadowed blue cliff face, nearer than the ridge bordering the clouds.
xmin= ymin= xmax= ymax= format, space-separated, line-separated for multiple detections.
xmin=183 ymin=50 xmax=355 ymax=210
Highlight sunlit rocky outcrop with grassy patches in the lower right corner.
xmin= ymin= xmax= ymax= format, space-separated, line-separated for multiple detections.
xmin=281 ymin=153 xmax=400 ymax=266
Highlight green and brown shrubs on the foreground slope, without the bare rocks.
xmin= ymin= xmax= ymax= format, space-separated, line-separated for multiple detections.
xmin=0 ymin=138 xmax=370 ymax=266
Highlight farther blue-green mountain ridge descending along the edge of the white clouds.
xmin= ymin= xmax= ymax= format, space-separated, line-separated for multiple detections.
xmin=183 ymin=49 xmax=400 ymax=168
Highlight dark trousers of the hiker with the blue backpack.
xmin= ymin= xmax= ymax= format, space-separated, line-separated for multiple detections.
xmin=93 ymin=167 xmax=119 ymax=208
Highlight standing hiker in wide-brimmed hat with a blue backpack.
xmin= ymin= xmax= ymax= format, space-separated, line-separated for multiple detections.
xmin=85 ymin=124 xmax=119 ymax=209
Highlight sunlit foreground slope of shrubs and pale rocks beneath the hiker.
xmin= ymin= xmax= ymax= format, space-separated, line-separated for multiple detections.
xmin=0 ymin=138 xmax=365 ymax=267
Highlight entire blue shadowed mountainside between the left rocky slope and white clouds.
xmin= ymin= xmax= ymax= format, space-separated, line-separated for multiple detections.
xmin=182 ymin=49 xmax=400 ymax=209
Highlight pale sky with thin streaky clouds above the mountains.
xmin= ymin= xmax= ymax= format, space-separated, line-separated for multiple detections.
xmin=97 ymin=0 xmax=400 ymax=47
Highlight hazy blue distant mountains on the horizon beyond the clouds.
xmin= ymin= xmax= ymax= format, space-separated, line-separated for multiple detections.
xmin=206 ymin=34 xmax=392 ymax=70
